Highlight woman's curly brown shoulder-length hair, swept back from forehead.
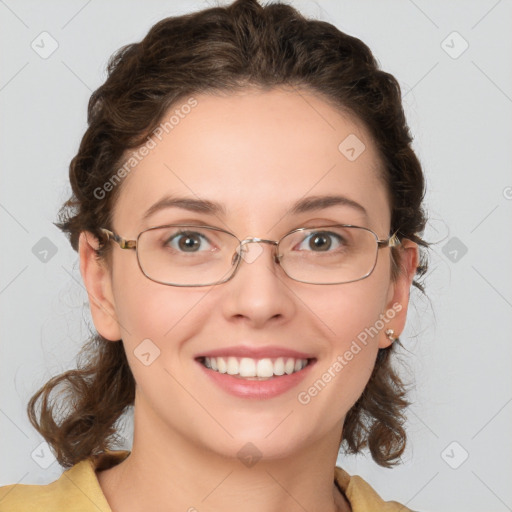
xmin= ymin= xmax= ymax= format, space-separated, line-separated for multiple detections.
xmin=27 ymin=0 xmax=428 ymax=467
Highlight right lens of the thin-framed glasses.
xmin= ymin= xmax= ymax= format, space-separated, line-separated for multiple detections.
xmin=279 ymin=226 xmax=378 ymax=284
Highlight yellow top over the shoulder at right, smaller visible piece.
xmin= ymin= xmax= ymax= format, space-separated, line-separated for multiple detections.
xmin=334 ymin=467 xmax=412 ymax=512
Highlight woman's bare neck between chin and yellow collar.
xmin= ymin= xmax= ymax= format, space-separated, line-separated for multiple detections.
xmin=97 ymin=394 xmax=350 ymax=512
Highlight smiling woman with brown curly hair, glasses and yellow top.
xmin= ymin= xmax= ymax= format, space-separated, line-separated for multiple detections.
xmin=0 ymin=0 xmax=427 ymax=512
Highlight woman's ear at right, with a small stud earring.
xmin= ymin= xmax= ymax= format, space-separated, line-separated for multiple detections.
xmin=379 ymin=239 xmax=419 ymax=348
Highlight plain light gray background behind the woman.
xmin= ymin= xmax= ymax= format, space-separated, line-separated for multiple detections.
xmin=0 ymin=0 xmax=512 ymax=512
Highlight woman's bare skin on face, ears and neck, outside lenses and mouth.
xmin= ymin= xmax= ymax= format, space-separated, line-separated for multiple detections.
xmin=79 ymin=88 xmax=418 ymax=512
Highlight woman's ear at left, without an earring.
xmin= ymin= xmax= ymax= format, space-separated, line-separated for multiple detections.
xmin=78 ymin=231 xmax=121 ymax=341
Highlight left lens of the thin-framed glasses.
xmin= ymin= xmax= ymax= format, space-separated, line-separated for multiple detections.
xmin=137 ymin=225 xmax=239 ymax=286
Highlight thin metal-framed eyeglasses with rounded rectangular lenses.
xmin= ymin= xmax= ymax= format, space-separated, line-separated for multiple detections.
xmin=100 ymin=224 xmax=400 ymax=286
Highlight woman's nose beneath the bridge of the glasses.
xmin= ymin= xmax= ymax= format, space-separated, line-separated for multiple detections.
xmin=223 ymin=238 xmax=296 ymax=327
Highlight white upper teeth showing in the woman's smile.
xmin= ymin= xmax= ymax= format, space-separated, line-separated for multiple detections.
xmin=204 ymin=357 xmax=308 ymax=377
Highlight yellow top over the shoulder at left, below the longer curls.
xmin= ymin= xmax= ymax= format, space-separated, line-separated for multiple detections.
xmin=0 ymin=450 xmax=129 ymax=512
